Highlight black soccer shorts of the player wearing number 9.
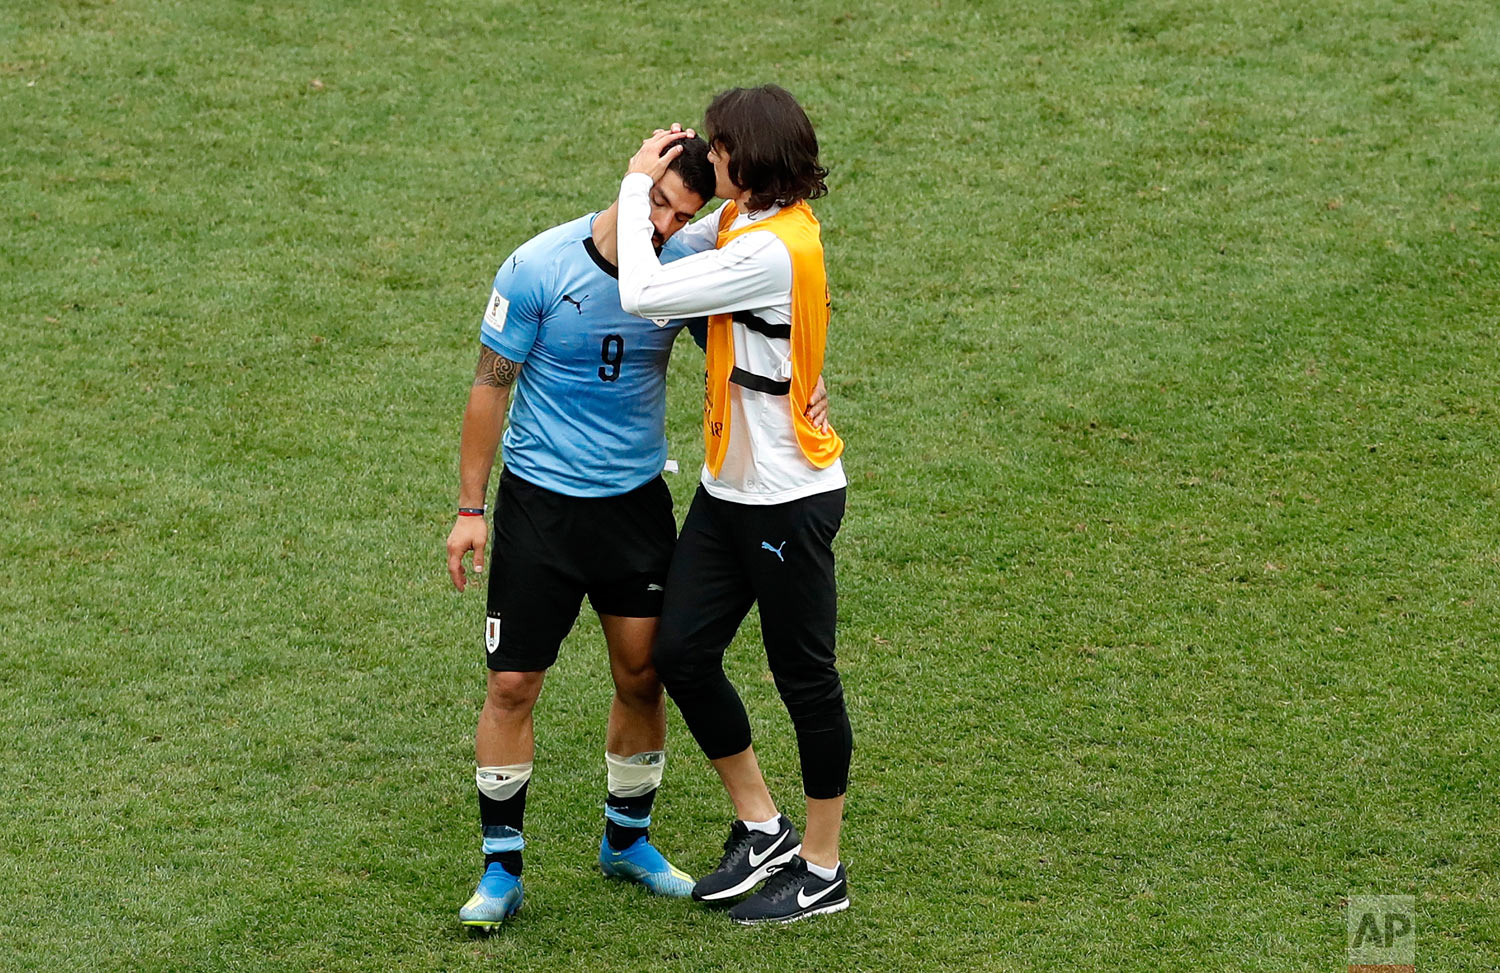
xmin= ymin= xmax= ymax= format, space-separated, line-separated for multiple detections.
xmin=485 ymin=469 xmax=677 ymax=672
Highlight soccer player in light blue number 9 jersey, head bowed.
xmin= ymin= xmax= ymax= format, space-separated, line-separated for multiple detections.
xmin=447 ymin=138 xmax=821 ymax=930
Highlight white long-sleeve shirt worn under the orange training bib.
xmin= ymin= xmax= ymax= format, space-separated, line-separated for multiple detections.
xmin=617 ymin=172 xmax=848 ymax=504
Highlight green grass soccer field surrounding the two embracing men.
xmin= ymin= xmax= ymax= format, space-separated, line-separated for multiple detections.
xmin=0 ymin=0 xmax=1500 ymax=972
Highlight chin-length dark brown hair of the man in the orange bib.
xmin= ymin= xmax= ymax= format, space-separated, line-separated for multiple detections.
xmin=704 ymin=84 xmax=828 ymax=210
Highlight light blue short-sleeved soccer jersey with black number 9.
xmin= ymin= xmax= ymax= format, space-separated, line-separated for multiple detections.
xmin=480 ymin=214 xmax=689 ymax=496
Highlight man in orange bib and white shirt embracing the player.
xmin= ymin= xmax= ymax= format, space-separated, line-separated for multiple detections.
xmin=618 ymin=85 xmax=854 ymax=924
